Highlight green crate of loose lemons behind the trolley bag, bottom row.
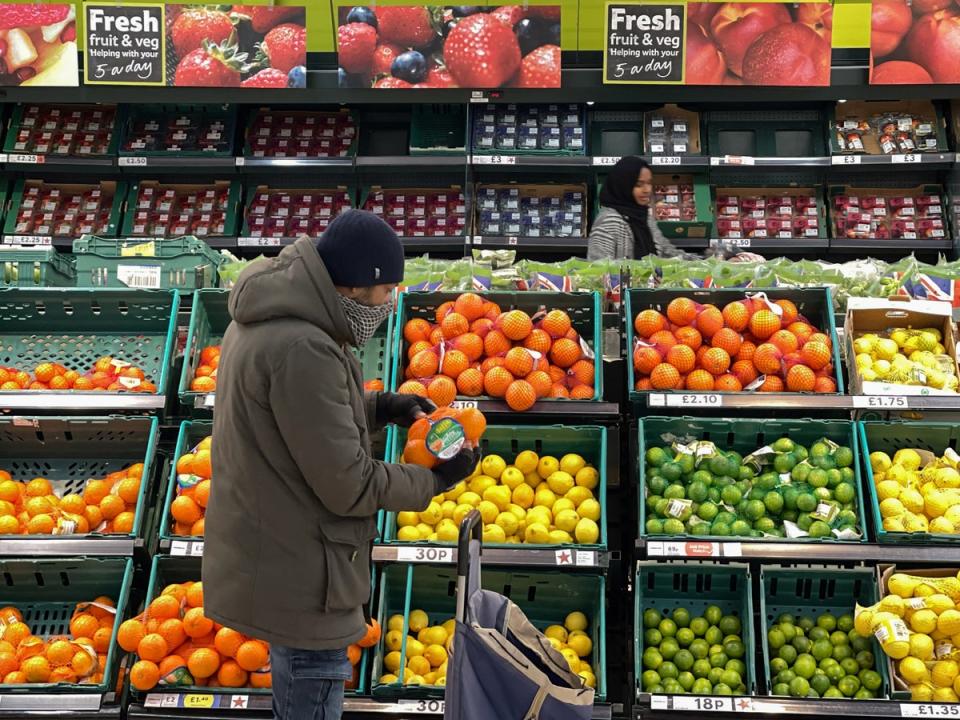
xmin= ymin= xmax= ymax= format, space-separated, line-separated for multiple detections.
xmin=371 ymin=564 xmax=607 ymax=702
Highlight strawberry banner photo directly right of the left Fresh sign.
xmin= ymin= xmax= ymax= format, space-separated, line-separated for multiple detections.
xmin=166 ymin=4 xmax=307 ymax=88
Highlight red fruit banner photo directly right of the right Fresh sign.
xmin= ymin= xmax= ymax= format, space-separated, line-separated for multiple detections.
xmin=686 ymin=2 xmax=833 ymax=86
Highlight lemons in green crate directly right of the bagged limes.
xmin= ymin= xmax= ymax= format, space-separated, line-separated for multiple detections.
xmin=870 ymin=448 xmax=960 ymax=535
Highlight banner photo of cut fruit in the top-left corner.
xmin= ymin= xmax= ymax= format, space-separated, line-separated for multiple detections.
xmin=0 ymin=3 xmax=80 ymax=87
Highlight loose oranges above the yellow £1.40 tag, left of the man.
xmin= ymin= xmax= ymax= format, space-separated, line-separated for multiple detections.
xmin=117 ymin=582 xmax=271 ymax=690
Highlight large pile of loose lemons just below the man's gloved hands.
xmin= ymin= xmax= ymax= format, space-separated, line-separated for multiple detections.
xmin=397 ymin=450 xmax=601 ymax=545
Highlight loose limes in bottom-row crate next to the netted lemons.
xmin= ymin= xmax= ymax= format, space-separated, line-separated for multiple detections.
xmin=767 ymin=612 xmax=882 ymax=700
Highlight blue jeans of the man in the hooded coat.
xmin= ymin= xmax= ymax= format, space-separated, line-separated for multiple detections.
xmin=270 ymin=645 xmax=353 ymax=720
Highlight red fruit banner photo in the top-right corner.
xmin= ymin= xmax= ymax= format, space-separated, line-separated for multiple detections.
xmin=870 ymin=0 xmax=960 ymax=85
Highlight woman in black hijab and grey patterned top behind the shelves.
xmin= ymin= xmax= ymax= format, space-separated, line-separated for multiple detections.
xmin=587 ymin=156 xmax=699 ymax=260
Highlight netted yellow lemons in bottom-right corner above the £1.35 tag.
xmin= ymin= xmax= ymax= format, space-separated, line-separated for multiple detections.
xmin=854 ymin=573 xmax=960 ymax=702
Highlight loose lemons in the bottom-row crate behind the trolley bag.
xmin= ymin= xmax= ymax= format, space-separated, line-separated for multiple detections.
xmin=380 ymin=610 xmax=597 ymax=688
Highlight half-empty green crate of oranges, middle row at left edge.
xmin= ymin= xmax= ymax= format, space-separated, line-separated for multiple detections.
xmin=0 ymin=416 xmax=159 ymax=544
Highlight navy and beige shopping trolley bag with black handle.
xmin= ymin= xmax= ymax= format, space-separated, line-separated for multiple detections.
xmin=443 ymin=510 xmax=594 ymax=720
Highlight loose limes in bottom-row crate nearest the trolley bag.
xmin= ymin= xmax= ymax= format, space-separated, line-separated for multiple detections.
xmin=640 ymin=605 xmax=748 ymax=695
